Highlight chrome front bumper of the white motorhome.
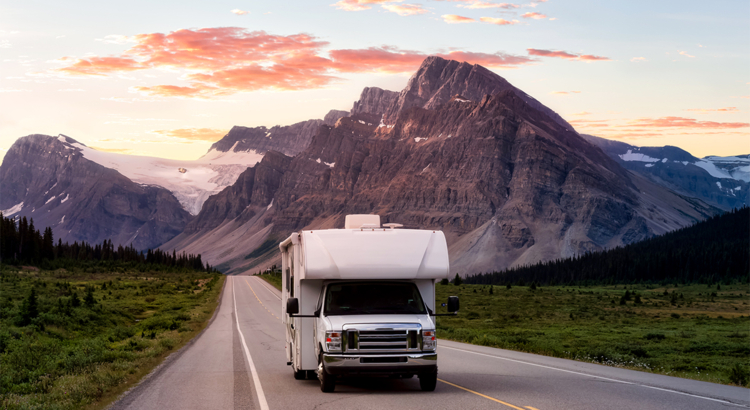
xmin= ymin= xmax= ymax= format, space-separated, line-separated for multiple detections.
xmin=323 ymin=353 xmax=437 ymax=375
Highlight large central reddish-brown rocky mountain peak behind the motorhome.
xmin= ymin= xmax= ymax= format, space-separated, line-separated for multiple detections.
xmin=165 ymin=58 xmax=719 ymax=274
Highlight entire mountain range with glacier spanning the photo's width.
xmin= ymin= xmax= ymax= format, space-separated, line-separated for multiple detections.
xmin=0 ymin=57 xmax=748 ymax=274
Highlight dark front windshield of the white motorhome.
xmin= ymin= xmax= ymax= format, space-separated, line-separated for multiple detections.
xmin=323 ymin=282 xmax=425 ymax=316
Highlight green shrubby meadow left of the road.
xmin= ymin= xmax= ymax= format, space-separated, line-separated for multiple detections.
xmin=0 ymin=265 xmax=225 ymax=409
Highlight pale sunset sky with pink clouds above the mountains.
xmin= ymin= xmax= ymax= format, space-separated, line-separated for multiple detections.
xmin=0 ymin=0 xmax=750 ymax=159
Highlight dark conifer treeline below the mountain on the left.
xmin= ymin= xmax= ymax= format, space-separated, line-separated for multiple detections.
xmin=0 ymin=213 xmax=216 ymax=272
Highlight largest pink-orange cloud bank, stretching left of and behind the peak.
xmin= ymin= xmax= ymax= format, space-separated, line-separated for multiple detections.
xmin=53 ymin=27 xmax=536 ymax=99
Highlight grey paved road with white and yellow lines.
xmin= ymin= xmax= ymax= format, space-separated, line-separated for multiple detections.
xmin=113 ymin=276 xmax=750 ymax=410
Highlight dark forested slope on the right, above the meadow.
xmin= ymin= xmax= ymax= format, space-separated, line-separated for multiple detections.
xmin=464 ymin=206 xmax=750 ymax=285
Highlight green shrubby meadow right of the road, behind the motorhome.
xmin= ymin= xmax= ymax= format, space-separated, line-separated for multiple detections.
xmin=436 ymin=284 xmax=750 ymax=386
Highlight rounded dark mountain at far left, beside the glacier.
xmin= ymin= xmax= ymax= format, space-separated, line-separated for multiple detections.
xmin=0 ymin=135 xmax=191 ymax=249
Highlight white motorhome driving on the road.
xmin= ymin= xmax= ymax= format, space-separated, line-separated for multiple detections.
xmin=279 ymin=215 xmax=458 ymax=392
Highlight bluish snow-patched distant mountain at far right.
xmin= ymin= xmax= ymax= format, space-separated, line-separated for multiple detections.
xmin=582 ymin=135 xmax=750 ymax=210
